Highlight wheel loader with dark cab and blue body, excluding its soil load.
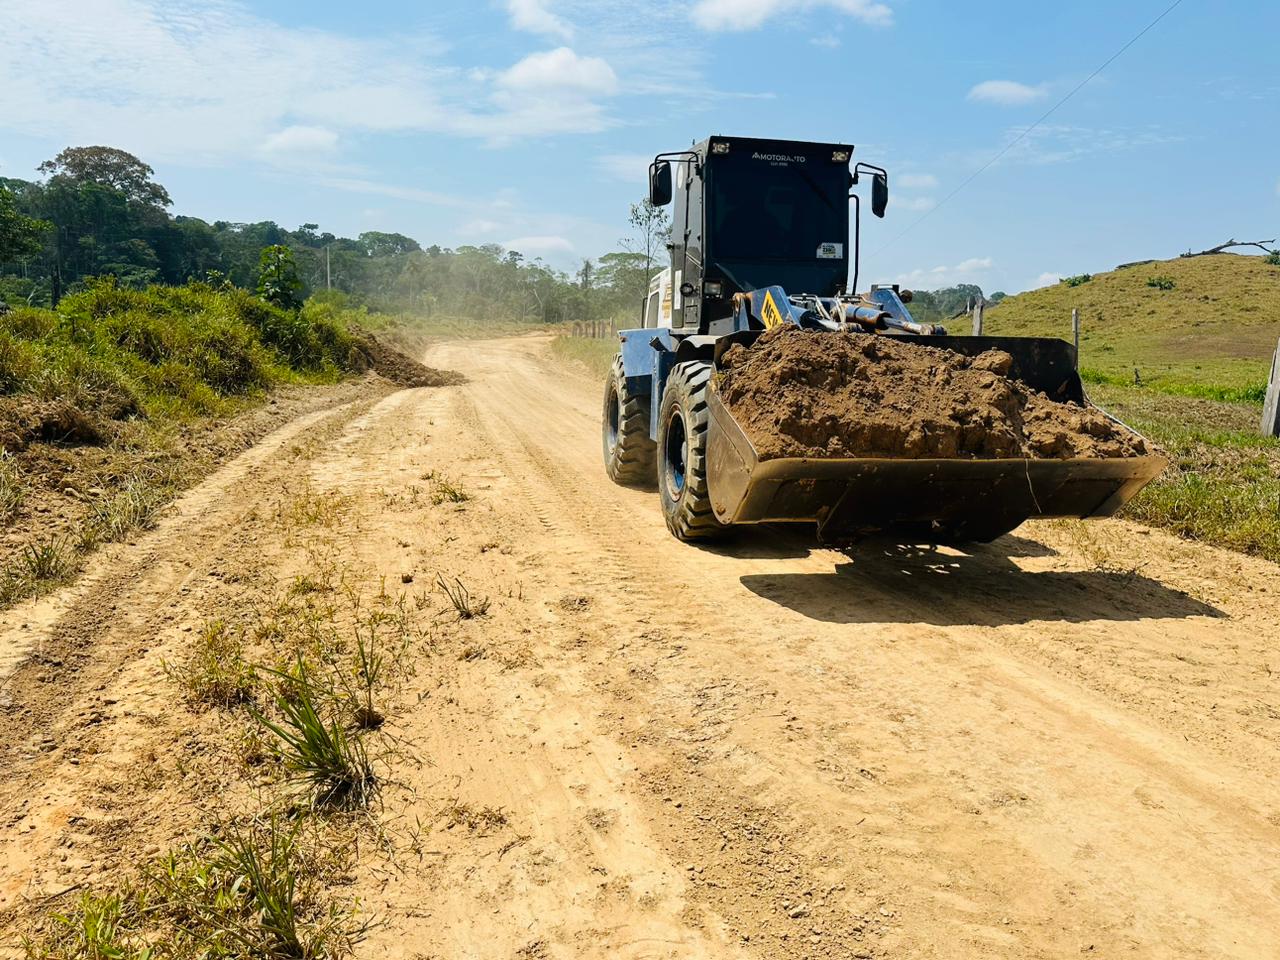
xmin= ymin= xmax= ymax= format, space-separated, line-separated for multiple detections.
xmin=602 ymin=137 xmax=1165 ymax=543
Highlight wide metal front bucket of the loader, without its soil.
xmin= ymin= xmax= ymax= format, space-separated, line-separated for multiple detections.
xmin=707 ymin=337 xmax=1166 ymax=541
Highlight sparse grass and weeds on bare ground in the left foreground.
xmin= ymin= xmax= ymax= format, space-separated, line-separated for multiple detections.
xmin=24 ymin=486 xmax=448 ymax=960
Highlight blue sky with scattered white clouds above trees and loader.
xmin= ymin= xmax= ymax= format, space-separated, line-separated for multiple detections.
xmin=0 ymin=0 xmax=1280 ymax=292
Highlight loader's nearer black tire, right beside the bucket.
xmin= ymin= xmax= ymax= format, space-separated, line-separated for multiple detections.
xmin=658 ymin=361 xmax=730 ymax=541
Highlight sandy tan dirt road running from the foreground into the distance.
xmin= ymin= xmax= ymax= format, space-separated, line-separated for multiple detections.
xmin=0 ymin=337 xmax=1280 ymax=959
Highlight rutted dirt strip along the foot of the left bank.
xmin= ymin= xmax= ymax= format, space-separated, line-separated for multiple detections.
xmin=0 ymin=389 xmax=380 ymax=915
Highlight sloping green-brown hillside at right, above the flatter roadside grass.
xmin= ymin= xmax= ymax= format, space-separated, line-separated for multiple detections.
xmin=984 ymin=253 xmax=1280 ymax=402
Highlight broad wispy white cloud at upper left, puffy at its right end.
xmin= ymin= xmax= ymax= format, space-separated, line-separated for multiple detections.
xmin=0 ymin=0 xmax=618 ymax=164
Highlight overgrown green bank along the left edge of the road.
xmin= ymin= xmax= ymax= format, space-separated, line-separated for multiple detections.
xmin=0 ymin=278 xmax=365 ymax=605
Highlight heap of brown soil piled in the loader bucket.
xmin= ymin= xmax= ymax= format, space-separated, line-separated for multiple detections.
xmin=718 ymin=328 xmax=1147 ymax=460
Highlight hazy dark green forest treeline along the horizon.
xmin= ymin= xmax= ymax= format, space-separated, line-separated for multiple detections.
xmin=0 ymin=146 xmax=998 ymax=323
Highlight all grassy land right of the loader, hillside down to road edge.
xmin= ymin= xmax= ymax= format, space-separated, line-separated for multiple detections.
xmin=987 ymin=253 xmax=1280 ymax=562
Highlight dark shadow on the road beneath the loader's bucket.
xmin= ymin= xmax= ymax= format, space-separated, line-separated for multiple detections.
xmin=740 ymin=538 xmax=1226 ymax=627
